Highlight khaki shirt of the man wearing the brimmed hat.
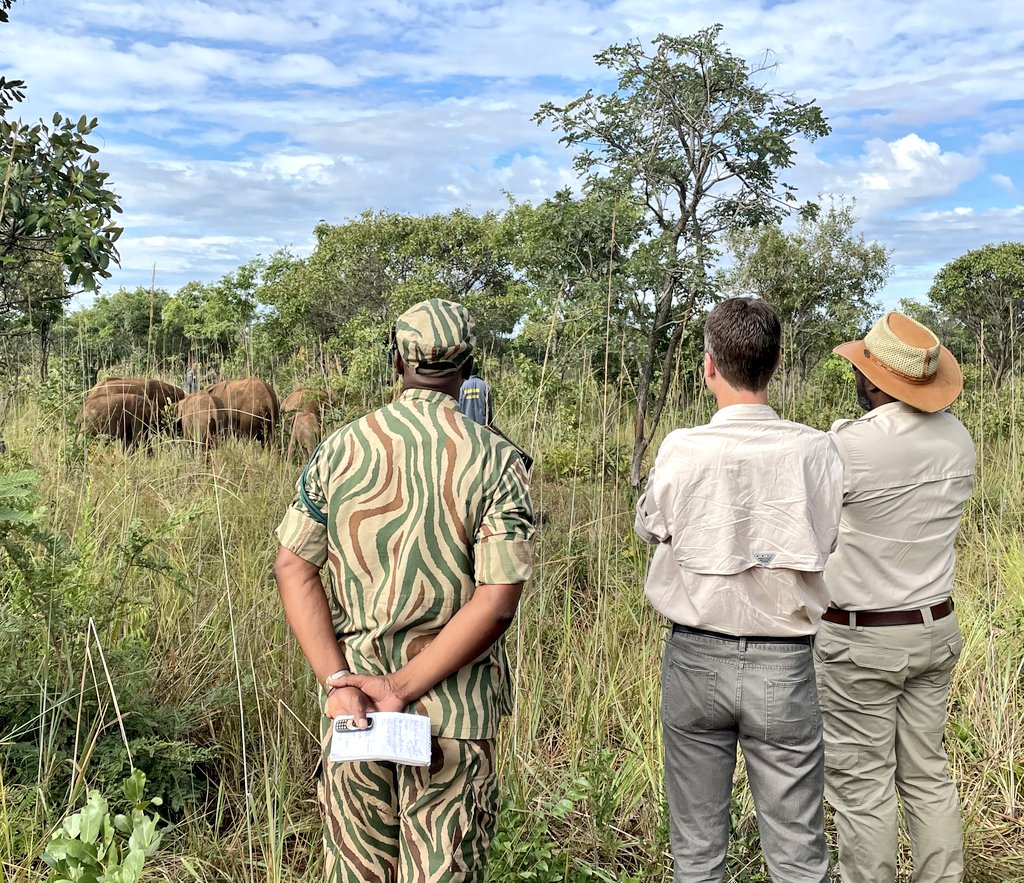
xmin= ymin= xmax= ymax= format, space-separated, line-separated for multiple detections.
xmin=825 ymin=402 xmax=975 ymax=611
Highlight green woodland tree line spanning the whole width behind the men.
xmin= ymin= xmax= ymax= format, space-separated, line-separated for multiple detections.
xmin=0 ymin=0 xmax=1024 ymax=483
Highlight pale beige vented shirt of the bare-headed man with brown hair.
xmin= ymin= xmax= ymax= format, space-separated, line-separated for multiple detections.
xmin=635 ymin=405 xmax=843 ymax=637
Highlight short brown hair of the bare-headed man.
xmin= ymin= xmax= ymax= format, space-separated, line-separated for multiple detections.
xmin=705 ymin=297 xmax=782 ymax=392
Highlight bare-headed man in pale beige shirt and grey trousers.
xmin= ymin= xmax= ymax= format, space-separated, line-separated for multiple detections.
xmin=636 ymin=298 xmax=843 ymax=883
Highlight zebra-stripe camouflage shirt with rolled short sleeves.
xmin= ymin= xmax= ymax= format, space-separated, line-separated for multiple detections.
xmin=278 ymin=389 xmax=534 ymax=739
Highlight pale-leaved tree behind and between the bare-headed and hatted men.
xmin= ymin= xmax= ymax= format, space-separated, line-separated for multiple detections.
xmin=724 ymin=206 xmax=890 ymax=389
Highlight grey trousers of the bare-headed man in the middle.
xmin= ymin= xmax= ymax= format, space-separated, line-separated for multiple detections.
xmin=662 ymin=631 xmax=828 ymax=883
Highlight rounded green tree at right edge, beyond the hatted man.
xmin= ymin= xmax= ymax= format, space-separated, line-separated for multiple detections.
xmin=928 ymin=242 xmax=1024 ymax=388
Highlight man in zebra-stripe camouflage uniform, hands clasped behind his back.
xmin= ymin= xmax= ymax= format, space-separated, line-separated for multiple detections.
xmin=274 ymin=299 xmax=534 ymax=883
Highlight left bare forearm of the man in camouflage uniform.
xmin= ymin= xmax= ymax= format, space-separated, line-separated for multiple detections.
xmin=273 ymin=546 xmax=346 ymax=683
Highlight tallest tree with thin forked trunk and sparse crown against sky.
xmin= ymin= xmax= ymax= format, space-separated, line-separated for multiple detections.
xmin=535 ymin=25 xmax=829 ymax=487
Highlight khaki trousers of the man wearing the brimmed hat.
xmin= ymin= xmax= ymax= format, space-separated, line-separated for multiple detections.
xmin=814 ymin=611 xmax=964 ymax=883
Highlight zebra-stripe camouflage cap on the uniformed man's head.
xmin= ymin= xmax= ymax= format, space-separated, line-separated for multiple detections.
xmin=394 ymin=297 xmax=476 ymax=377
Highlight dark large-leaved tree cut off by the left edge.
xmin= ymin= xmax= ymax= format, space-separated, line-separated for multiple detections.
xmin=0 ymin=0 xmax=121 ymax=373
